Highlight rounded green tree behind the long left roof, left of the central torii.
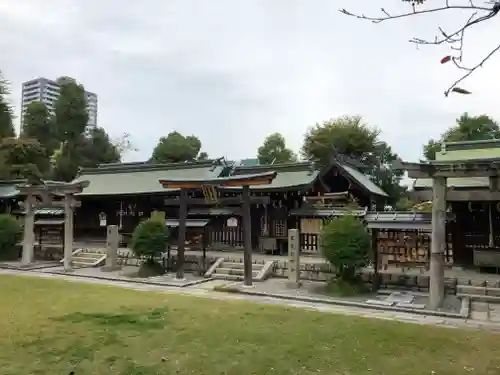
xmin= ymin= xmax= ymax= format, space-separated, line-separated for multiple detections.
xmin=151 ymin=131 xmax=207 ymax=163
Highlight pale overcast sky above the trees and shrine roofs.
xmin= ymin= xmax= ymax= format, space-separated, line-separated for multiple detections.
xmin=0 ymin=0 xmax=500 ymax=164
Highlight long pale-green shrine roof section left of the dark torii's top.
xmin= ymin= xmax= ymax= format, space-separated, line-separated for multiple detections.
xmin=74 ymin=159 xmax=226 ymax=196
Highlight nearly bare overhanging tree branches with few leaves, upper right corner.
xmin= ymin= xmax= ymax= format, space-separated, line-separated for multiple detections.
xmin=340 ymin=0 xmax=500 ymax=96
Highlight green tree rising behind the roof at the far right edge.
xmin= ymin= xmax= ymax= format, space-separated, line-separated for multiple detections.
xmin=424 ymin=112 xmax=500 ymax=160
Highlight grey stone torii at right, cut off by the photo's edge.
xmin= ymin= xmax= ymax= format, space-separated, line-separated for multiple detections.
xmin=393 ymin=159 xmax=500 ymax=309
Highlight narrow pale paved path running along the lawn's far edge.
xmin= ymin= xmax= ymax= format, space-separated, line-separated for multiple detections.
xmin=0 ymin=269 xmax=500 ymax=332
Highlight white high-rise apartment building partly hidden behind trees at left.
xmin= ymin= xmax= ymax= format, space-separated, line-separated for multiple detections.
xmin=21 ymin=78 xmax=97 ymax=126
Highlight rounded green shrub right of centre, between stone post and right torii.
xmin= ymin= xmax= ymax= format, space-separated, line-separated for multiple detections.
xmin=320 ymin=215 xmax=371 ymax=281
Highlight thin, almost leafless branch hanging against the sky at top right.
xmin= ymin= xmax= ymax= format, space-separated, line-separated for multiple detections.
xmin=340 ymin=0 xmax=500 ymax=96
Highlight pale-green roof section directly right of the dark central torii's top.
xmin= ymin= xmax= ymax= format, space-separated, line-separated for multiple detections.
xmin=227 ymin=162 xmax=319 ymax=191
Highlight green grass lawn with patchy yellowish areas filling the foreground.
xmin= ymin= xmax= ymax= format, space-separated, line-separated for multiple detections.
xmin=0 ymin=276 xmax=500 ymax=375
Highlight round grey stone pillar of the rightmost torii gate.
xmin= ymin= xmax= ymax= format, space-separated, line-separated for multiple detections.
xmin=429 ymin=177 xmax=446 ymax=310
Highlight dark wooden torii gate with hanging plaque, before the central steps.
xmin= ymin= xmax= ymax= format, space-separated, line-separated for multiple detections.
xmin=160 ymin=172 xmax=277 ymax=286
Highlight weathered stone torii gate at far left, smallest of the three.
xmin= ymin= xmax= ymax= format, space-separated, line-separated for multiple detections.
xmin=17 ymin=181 xmax=90 ymax=272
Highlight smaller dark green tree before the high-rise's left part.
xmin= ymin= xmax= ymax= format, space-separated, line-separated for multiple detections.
xmin=21 ymin=101 xmax=59 ymax=158
